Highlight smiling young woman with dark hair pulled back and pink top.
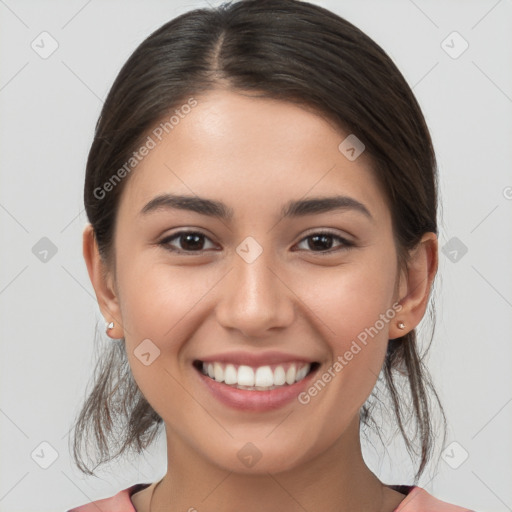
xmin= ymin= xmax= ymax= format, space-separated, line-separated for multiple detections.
xmin=67 ymin=0 xmax=476 ymax=512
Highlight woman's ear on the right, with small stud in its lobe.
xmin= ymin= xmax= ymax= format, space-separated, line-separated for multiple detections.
xmin=389 ymin=233 xmax=438 ymax=339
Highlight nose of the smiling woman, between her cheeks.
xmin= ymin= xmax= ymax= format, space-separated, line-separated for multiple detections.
xmin=216 ymin=246 xmax=295 ymax=338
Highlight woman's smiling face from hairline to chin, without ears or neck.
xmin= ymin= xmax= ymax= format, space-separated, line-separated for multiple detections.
xmin=106 ymin=91 xmax=408 ymax=472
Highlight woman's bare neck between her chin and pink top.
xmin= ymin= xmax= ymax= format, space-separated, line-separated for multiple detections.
xmin=150 ymin=418 xmax=394 ymax=512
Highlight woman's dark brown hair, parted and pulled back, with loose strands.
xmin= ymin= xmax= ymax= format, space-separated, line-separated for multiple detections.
xmin=73 ymin=0 xmax=446 ymax=482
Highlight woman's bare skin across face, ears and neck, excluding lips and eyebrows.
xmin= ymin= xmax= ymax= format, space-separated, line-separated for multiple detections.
xmin=83 ymin=90 xmax=437 ymax=512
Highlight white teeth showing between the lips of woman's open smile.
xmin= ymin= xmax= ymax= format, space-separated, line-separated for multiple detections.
xmin=193 ymin=360 xmax=320 ymax=391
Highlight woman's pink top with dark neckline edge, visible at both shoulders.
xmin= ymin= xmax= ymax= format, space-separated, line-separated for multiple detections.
xmin=67 ymin=484 xmax=472 ymax=512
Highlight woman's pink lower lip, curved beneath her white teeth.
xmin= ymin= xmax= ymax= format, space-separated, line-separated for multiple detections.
xmin=195 ymin=368 xmax=318 ymax=412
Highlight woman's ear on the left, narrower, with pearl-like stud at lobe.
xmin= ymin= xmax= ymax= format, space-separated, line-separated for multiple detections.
xmin=82 ymin=224 xmax=123 ymax=339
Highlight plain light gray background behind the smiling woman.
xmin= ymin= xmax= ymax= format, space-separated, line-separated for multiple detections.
xmin=0 ymin=0 xmax=512 ymax=512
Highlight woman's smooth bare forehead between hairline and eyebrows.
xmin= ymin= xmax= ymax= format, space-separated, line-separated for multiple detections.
xmin=116 ymin=90 xmax=386 ymax=222
